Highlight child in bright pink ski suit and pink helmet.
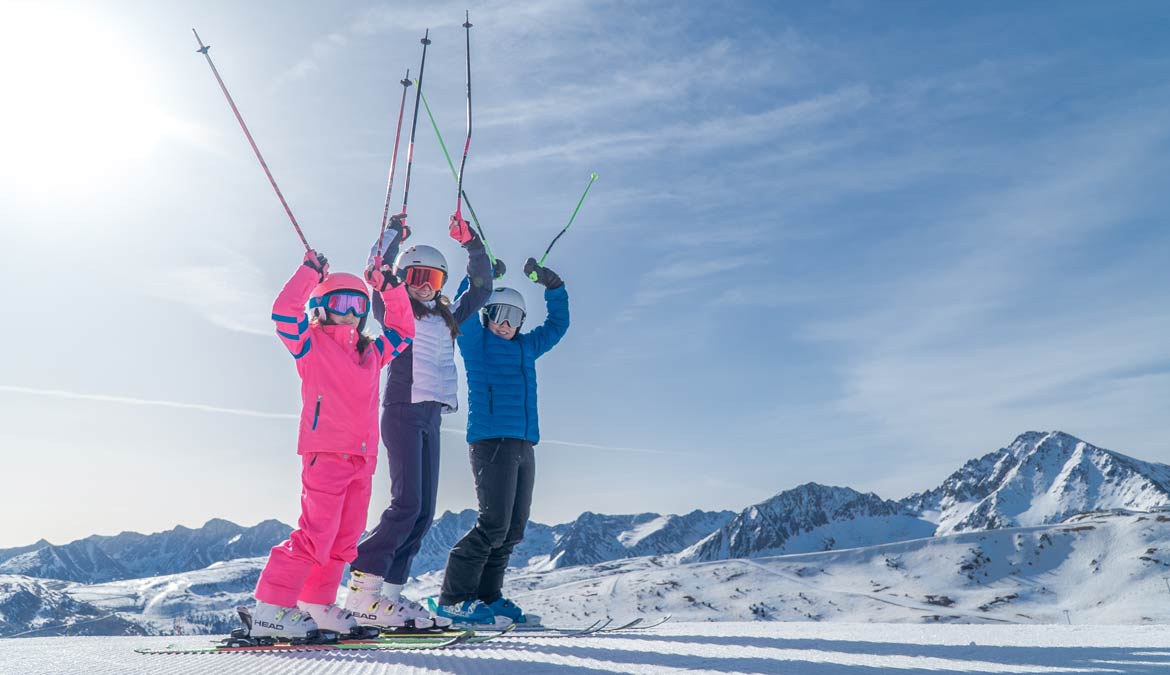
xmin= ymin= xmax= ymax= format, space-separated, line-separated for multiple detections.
xmin=250 ymin=223 xmax=414 ymax=639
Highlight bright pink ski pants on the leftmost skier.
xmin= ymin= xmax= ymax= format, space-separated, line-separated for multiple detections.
xmin=256 ymin=453 xmax=377 ymax=607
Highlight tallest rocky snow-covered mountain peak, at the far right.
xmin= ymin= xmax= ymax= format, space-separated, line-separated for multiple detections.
xmin=901 ymin=432 xmax=1170 ymax=535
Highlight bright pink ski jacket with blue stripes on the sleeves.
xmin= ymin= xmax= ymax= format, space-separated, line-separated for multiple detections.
xmin=273 ymin=266 xmax=414 ymax=459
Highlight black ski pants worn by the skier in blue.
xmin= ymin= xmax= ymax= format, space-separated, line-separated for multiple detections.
xmin=439 ymin=439 xmax=536 ymax=605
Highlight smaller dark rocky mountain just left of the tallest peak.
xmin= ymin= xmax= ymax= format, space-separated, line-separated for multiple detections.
xmin=679 ymin=483 xmax=935 ymax=563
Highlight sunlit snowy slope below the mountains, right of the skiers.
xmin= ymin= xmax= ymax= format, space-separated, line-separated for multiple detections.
xmin=449 ymin=514 xmax=1170 ymax=624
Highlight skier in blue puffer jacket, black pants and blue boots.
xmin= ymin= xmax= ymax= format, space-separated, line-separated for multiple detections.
xmin=432 ymin=257 xmax=569 ymax=626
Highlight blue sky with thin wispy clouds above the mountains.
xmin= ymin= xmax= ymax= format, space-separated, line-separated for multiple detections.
xmin=0 ymin=1 xmax=1170 ymax=546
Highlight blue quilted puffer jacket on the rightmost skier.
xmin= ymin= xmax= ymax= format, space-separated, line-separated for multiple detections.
xmin=459 ymin=287 xmax=569 ymax=445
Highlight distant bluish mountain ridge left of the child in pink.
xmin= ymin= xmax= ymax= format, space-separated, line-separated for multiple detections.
xmin=0 ymin=518 xmax=291 ymax=583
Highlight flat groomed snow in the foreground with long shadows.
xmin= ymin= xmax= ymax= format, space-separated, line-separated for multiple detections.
xmin=0 ymin=622 xmax=1170 ymax=675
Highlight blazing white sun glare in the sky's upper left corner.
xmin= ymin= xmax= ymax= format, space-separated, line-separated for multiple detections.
xmin=0 ymin=2 xmax=180 ymax=195
